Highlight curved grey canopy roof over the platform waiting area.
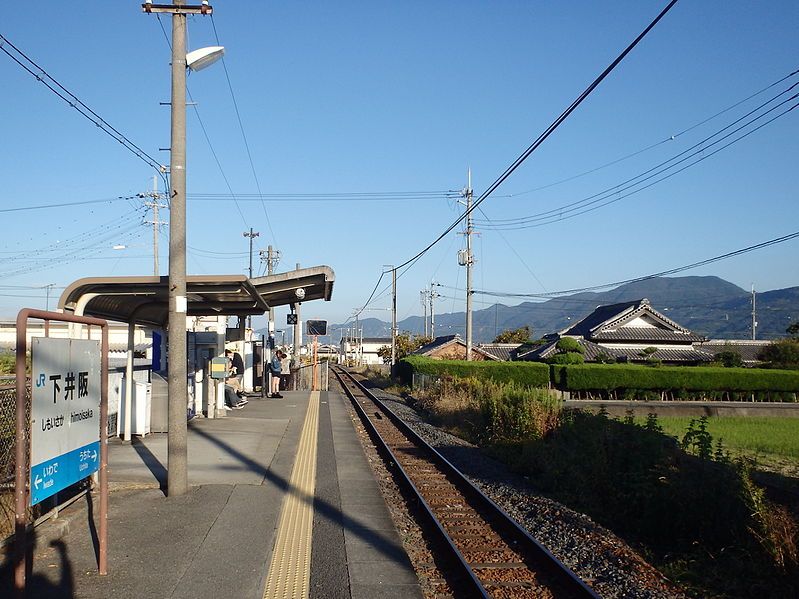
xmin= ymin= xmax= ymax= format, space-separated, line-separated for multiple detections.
xmin=58 ymin=266 xmax=335 ymax=327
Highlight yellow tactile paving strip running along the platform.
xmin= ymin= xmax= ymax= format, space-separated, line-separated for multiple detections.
xmin=264 ymin=391 xmax=319 ymax=599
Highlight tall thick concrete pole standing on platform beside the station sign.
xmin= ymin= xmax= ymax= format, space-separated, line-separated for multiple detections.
xmin=142 ymin=2 xmax=213 ymax=497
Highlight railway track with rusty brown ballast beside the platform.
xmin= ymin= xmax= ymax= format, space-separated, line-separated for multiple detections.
xmin=333 ymin=367 xmax=598 ymax=598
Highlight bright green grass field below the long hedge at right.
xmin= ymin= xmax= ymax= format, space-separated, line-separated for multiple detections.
xmin=636 ymin=417 xmax=799 ymax=476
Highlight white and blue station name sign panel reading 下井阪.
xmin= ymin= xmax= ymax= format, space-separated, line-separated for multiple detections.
xmin=30 ymin=337 xmax=101 ymax=505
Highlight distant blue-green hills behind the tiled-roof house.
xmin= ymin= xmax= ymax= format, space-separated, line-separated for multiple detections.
xmin=331 ymin=277 xmax=799 ymax=343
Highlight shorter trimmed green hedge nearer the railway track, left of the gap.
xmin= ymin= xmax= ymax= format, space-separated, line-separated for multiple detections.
xmin=399 ymin=356 xmax=549 ymax=387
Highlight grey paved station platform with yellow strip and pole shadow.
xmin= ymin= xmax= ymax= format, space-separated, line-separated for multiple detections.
xmin=0 ymin=391 xmax=422 ymax=599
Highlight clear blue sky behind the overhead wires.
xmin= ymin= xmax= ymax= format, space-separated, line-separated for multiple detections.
xmin=0 ymin=0 xmax=799 ymax=326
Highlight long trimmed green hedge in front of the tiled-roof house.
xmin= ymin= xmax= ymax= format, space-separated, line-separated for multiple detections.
xmin=552 ymin=364 xmax=799 ymax=393
